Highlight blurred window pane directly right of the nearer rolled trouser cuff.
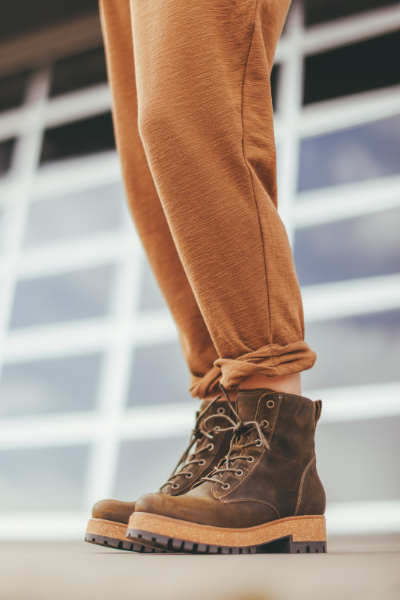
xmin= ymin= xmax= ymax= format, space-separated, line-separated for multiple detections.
xmin=302 ymin=311 xmax=400 ymax=390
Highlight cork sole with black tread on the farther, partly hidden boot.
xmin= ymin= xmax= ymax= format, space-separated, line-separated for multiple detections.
xmin=85 ymin=519 xmax=167 ymax=554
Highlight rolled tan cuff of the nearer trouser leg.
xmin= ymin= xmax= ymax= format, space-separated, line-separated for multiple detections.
xmin=214 ymin=342 xmax=317 ymax=388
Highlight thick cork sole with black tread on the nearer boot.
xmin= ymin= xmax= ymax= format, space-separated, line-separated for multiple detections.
xmin=126 ymin=512 xmax=326 ymax=554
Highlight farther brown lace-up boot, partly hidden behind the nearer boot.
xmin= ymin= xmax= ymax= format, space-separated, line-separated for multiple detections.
xmin=85 ymin=397 xmax=235 ymax=552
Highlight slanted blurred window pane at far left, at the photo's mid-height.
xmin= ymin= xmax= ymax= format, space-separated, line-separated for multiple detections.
xmin=10 ymin=266 xmax=114 ymax=329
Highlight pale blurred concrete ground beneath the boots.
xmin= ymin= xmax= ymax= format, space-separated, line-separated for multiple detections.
xmin=0 ymin=536 xmax=400 ymax=600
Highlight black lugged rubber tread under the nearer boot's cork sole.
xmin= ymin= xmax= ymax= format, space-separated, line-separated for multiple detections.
xmin=127 ymin=529 xmax=327 ymax=554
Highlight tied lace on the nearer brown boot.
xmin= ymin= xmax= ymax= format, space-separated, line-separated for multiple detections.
xmin=201 ymin=384 xmax=270 ymax=489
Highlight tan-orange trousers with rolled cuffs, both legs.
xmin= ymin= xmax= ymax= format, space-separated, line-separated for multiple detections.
xmin=101 ymin=0 xmax=315 ymax=398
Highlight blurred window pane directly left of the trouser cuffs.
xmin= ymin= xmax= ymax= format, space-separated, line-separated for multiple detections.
xmin=128 ymin=343 xmax=190 ymax=406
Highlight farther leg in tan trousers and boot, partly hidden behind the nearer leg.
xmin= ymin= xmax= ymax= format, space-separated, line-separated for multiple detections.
xmin=85 ymin=0 xmax=238 ymax=552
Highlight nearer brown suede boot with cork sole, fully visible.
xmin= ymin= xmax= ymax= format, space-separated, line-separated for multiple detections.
xmin=127 ymin=389 xmax=326 ymax=554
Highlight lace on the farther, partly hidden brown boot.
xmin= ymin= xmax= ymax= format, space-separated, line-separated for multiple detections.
xmin=160 ymin=396 xmax=234 ymax=490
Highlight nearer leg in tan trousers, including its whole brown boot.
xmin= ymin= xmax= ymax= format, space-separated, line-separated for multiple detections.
xmin=127 ymin=0 xmax=326 ymax=554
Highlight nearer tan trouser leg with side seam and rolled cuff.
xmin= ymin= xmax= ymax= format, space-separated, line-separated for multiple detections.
xmin=131 ymin=0 xmax=315 ymax=388
